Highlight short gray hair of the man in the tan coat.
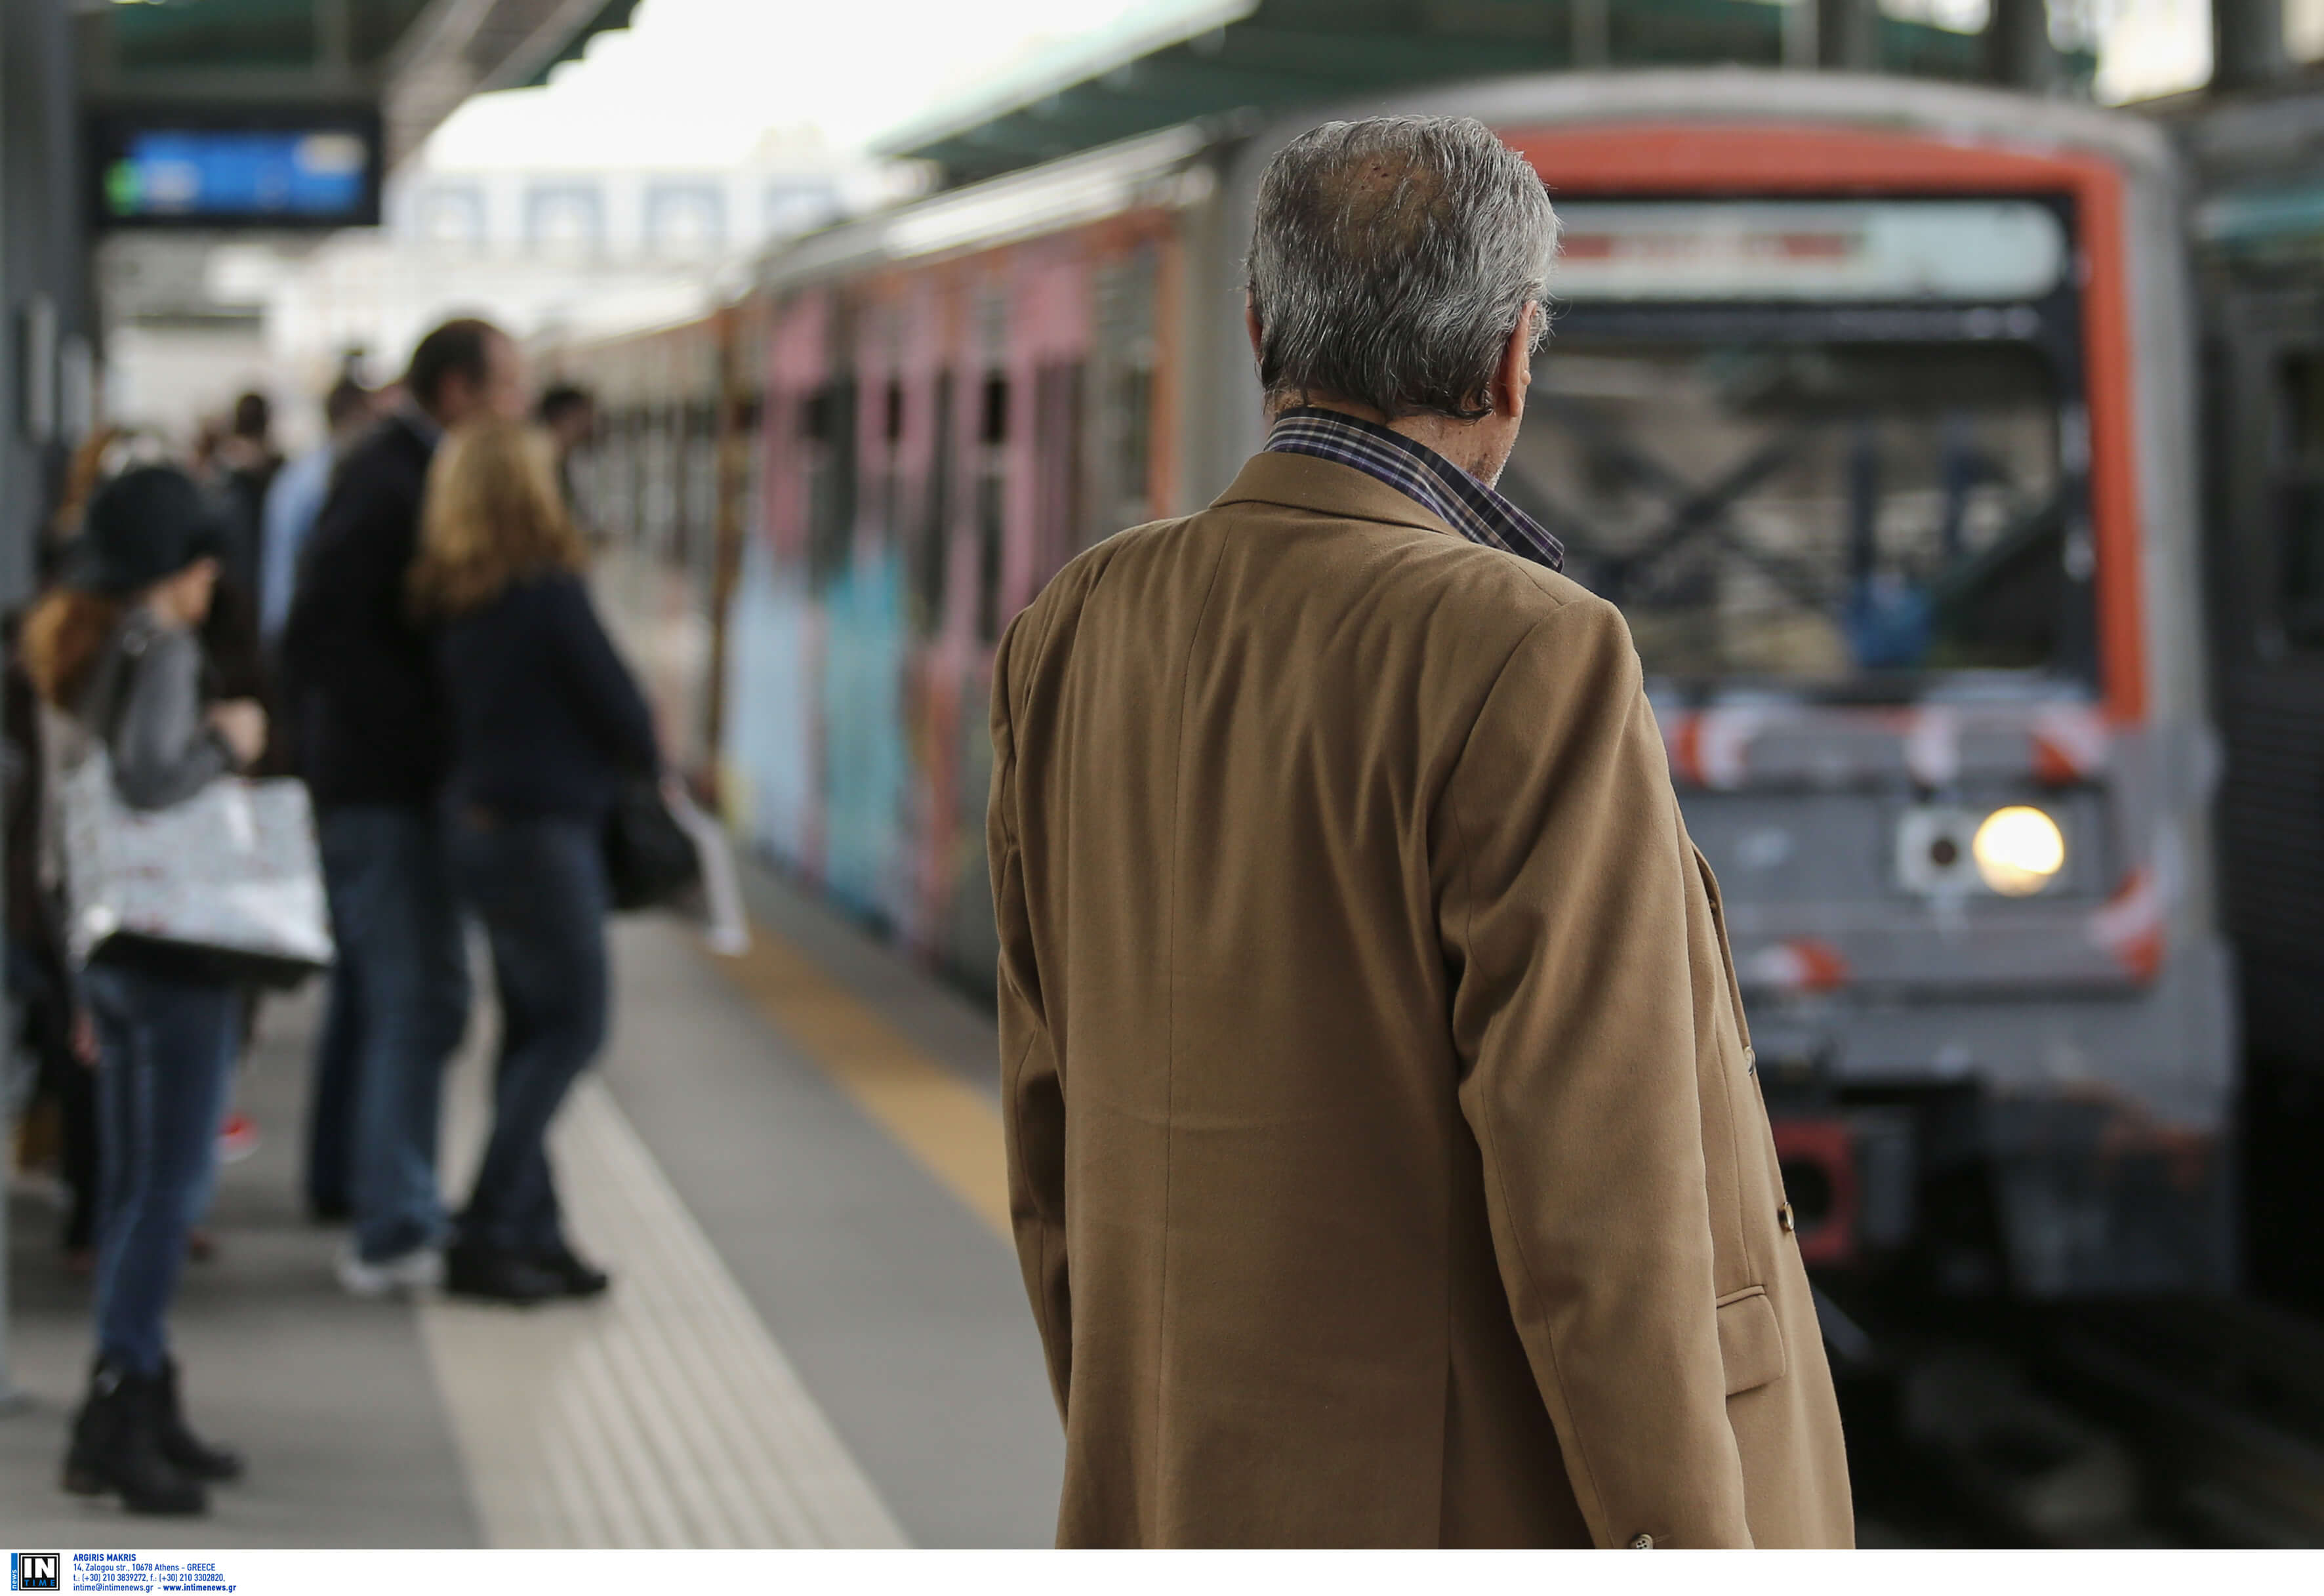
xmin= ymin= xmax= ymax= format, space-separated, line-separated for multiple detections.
xmin=1250 ymin=116 xmax=1557 ymax=420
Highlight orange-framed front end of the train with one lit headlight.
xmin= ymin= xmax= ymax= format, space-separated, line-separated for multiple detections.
xmin=1459 ymin=79 xmax=2233 ymax=1296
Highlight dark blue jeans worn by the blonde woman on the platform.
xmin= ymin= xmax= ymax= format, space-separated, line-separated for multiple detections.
xmin=453 ymin=820 xmax=609 ymax=1254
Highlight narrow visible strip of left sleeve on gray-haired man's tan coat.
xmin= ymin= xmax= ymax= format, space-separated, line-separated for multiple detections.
xmin=985 ymin=611 xmax=1074 ymax=1415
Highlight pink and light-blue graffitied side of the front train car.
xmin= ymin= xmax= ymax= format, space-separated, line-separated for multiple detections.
xmin=723 ymin=218 xmax=1167 ymax=981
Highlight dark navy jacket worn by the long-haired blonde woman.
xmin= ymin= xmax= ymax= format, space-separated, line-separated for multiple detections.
xmin=437 ymin=574 xmax=658 ymax=823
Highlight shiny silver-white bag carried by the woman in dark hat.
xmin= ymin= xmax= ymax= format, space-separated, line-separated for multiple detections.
xmin=58 ymin=748 xmax=335 ymax=985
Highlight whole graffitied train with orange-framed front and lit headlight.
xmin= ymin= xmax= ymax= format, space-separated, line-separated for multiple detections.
xmin=544 ymin=68 xmax=2243 ymax=1299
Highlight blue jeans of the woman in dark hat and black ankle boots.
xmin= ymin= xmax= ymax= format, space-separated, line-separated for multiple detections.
xmin=89 ymin=962 xmax=241 ymax=1376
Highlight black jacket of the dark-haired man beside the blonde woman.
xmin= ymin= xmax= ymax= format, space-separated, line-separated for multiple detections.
xmin=281 ymin=416 xmax=449 ymax=808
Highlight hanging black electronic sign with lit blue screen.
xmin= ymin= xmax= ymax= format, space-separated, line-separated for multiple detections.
xmin=91 ymin=107 xmax=381 ymax=230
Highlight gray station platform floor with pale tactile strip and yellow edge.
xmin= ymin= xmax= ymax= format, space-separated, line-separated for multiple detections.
xmin=0 ymin=874 xmax=1065 ymax=1547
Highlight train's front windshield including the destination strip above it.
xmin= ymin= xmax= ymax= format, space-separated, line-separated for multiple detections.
xmin=1501 ymin=200 xmax=2094 ymax=702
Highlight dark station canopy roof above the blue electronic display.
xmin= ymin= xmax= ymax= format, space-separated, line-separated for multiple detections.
xmin=91 ymin=0 xmax=637 ymax=163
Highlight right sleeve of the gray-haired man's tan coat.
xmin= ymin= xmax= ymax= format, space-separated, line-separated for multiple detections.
xmin=1434 ymin=600 xmax=1750 ymax=1547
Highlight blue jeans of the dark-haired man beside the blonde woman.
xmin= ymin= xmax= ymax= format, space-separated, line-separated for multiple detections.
xmin=316 ymin=806 xmax=467 ymax=1264
